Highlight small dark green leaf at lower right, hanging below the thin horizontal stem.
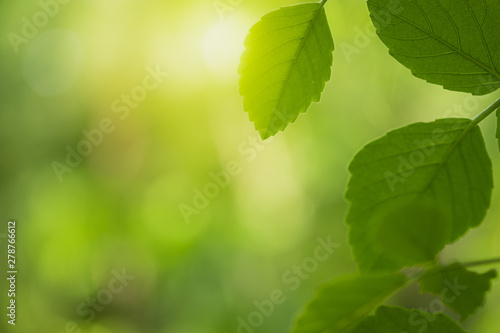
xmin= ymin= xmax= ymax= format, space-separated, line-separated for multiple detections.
xmin=419 ymin=263 xmax=497 ymax=320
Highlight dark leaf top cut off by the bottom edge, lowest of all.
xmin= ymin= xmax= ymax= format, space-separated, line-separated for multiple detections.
xmin=353 ymin=306 xmax=465 ymax=333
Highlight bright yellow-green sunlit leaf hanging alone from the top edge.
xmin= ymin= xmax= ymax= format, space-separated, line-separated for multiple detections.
xmin=238 ymin=1 xmax=334 ymax=139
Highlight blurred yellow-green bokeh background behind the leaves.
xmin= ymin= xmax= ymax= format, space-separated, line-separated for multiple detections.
xmin=0 ymin=0 xmax=500 ymax=333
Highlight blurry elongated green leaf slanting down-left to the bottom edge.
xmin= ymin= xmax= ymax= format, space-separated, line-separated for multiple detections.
xmin=292 ymin=273 xmax=408 ymax=333
